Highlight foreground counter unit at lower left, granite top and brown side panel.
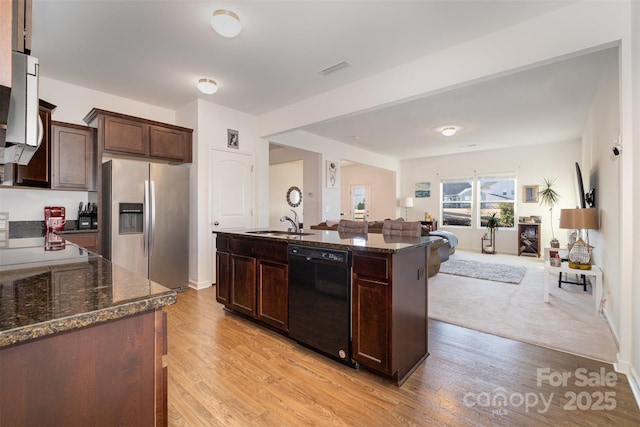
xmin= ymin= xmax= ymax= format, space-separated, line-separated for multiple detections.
xmin=0 ymin=238 xmax=177 ymax=426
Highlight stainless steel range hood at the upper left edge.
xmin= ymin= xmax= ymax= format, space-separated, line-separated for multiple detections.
xmin=0 ymin=52 xmax=44 ymax=165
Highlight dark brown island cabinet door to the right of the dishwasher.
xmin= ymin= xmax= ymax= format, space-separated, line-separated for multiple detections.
xmin=352 ymin=275 xmax=391 ymax=374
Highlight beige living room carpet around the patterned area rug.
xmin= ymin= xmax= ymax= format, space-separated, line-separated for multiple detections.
xmin=429 ymin=250 xmax=618 ymax=362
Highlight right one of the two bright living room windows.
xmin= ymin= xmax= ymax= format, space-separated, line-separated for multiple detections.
xmin=478 ymin=176 xmax=516 ymax=228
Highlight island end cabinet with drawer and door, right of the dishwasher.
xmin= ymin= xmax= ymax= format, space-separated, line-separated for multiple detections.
xmin=352 ymin=246 xmax=428 ymax=384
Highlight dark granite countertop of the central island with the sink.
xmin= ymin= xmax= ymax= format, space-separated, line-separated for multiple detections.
xmin=213 ymin=229 xmax=442 ymax=253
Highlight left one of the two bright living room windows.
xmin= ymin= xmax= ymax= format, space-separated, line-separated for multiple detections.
xmin=440 ymin=179 xmax=473 ymax=227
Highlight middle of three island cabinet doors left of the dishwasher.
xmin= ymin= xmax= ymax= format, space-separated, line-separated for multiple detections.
xmin=229 ymin=255 xmax=256 ymax=317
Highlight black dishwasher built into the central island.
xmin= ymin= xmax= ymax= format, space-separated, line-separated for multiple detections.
xmin=289 ymin=245 xmax=358 ymax=368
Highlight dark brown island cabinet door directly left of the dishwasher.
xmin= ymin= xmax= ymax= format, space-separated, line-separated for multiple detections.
xmin=257 ymin=260 xmax=289 ymax=331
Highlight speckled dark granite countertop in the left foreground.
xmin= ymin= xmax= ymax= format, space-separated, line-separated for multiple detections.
xmin=0 ymin=238 xmax=177 ymax=348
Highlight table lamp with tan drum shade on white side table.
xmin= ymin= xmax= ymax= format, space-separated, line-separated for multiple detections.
xmin=560 ymin=208 xmax=599 ymax=270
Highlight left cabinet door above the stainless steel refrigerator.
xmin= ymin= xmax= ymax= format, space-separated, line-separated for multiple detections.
xmin=104 ymin=116 xmax=149 ymax=155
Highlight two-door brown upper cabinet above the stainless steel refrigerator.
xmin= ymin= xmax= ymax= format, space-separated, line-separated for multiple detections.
xmin=84 ymin=108 xmax=193 ymax=163
